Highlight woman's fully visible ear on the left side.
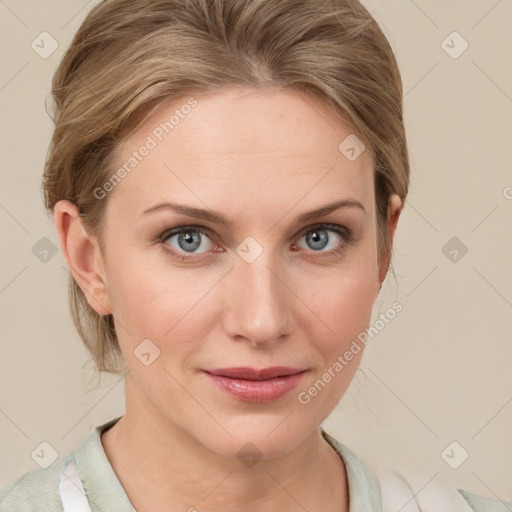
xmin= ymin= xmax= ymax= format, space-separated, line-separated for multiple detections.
xmin=53 ymin=200 xmax=112 ymax=315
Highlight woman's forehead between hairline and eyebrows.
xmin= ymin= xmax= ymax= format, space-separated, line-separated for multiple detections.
xmin=108 ymin=88 xmax=373 ymax=222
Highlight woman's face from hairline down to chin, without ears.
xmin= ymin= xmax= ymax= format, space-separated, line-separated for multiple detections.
xmin=91 ymin=89 xmax=396 ymax=458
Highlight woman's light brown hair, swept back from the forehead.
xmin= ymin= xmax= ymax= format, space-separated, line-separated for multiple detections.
xmin=43 ymin=0 xmax=409 ymax=374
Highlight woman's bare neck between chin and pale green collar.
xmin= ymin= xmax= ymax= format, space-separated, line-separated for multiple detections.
xmin=101 ymin=379 xmax=348 ymax=512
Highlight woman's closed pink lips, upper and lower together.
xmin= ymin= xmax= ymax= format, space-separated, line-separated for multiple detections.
xmin=204 ymin=366 xmax=308 ymax=403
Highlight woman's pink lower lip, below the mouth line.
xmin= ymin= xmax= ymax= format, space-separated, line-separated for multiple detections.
xmin=205 ymin=371 xmax=306 ymax=404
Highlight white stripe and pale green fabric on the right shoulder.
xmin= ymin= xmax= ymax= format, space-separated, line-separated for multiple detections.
xmin=378 ymin=470 xmax=512 ymax=512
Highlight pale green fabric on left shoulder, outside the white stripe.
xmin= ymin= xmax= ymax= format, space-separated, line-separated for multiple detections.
xmin=0 ymin=456 xmax=69 ymax=512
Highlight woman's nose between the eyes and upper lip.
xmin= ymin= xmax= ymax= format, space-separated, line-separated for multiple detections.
xmin=223 ymin=251 xmax=294 ymax=347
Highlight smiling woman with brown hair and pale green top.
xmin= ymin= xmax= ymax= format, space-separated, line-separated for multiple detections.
xmin=0 ymin=0 xmax=506 ymax=512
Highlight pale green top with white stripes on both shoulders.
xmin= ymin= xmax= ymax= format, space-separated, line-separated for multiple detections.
xmin=0 ymin=417 xmax=512 ymax=512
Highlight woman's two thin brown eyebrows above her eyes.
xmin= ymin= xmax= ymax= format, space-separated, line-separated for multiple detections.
xmin=141 ymin=199 xmax=366 ymax=229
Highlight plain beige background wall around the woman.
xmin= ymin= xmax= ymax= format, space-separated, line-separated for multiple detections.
xmin=0 ymin=0 xmax=512 ymax=499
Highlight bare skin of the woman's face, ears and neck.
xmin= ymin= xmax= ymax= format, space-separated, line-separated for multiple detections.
xmin=55 ymin=89 xmax=401 ymax=512
